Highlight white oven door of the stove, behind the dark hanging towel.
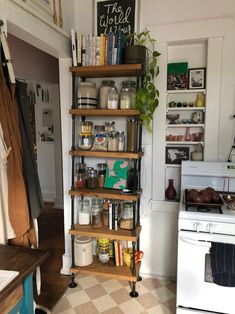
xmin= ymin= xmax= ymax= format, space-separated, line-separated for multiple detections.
xmin=177 ymin=231 xmax=235 ymax=314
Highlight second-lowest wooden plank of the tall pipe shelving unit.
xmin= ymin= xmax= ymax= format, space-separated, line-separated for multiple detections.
xmin=69 ymin=224 xmax=141 ymax=242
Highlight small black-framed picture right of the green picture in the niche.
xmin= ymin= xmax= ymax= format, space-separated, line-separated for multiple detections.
xmin=188 ymin=68 xmax=206 ymax=89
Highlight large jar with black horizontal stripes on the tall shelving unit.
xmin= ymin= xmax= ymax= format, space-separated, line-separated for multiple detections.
xmin=77 ymin=82 xmax=97 ymax=109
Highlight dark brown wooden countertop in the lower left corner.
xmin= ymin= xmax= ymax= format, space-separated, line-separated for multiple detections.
xmin=0 ymin=245 xmax=49 ymax=302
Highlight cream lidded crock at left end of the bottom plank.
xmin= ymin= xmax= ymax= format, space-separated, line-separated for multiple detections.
xmin=74 ymin=236 xmax=93 ymax=266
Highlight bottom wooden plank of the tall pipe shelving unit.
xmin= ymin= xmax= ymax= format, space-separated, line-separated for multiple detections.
xmin=70 ymin=256 xmax=140 ymax=282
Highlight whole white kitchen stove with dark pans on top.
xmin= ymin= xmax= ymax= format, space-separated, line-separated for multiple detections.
xmin=177 ymin=161 xmax=235 ymax=314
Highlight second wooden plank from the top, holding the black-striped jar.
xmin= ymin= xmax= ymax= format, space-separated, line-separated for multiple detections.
xmin=69 ymin=109 xmax=140 ymax=117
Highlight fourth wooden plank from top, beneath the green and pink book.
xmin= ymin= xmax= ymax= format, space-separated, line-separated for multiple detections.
xmin=69 ymin=188 xmax=141 ymax=201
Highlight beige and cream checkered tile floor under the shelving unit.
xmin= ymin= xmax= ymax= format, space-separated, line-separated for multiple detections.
xmin=51 ymin=275 xmax=176 ymax=314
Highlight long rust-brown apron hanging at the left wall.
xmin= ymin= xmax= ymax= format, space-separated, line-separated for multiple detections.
xmin=0 ymin=65 xmax=37 ymax=247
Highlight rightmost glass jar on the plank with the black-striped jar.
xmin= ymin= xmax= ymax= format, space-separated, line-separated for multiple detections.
xmin=120 ymin=81 xmax=136 ymax=109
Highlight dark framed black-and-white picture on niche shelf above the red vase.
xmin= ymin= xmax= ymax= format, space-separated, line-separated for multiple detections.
xmin=165 ymin=146 xmax=189 ymax=165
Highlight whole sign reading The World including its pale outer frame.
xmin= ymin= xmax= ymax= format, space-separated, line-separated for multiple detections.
xmin=93 ymin=0 xmax=140 ymax=36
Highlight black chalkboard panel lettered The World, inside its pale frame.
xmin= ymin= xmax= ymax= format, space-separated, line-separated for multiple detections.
xmin=95 ymin=0 xmax=138 ymax=35
